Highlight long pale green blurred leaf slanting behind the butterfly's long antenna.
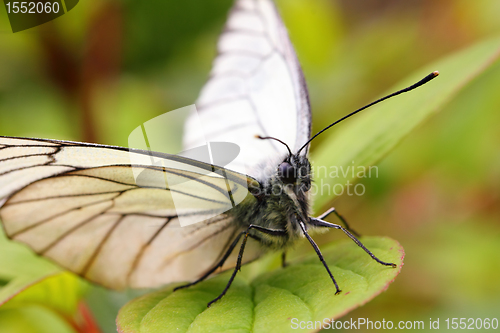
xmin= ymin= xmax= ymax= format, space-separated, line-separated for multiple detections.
xmin=311 ymin=34 xmax=500 ymax=210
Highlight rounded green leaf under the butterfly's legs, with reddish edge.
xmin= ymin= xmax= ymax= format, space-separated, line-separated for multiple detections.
xmin=117 ymin=237 xmax=404 ymax=333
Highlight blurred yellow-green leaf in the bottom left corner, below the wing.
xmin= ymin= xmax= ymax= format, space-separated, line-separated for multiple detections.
xmin=0 ymin=228 xmax=87 ymax=333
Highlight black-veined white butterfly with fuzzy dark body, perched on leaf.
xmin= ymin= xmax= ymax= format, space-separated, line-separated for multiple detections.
xmin=0 ymin=0 xmax=438 ymax=306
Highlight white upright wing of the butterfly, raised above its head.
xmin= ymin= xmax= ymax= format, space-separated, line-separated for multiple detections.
xmin=184 ymin=0 xmax=311 ymax=179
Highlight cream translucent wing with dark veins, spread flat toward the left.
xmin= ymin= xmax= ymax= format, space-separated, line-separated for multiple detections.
xmin=0 ymin=137 xmax=264 ymax=289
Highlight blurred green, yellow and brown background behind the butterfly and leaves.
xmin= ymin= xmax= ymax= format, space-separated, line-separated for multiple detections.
xmin=0 ymin=0 xmax=500 ymax=332
